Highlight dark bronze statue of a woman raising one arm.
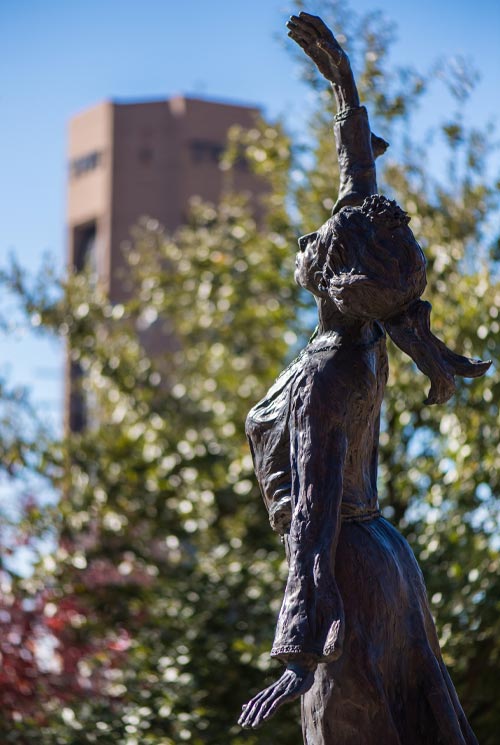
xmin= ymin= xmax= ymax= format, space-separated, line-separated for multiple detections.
xmin=240 ymin=13 xmax=489 ymax=745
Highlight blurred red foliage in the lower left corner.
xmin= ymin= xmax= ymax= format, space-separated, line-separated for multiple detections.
xmin=0 ymin=572 xmax=130 ymax=724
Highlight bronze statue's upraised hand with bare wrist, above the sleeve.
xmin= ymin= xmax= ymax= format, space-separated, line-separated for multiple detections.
xmin=287 ymin=12 xmax=359 ymax=106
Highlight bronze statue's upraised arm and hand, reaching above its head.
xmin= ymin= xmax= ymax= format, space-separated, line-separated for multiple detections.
xmin=287 ymin=12 xmax=388 ymax=214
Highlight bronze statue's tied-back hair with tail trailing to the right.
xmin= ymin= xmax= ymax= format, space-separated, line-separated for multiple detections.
xmin=310 ymin=194 xmax=491 ymax=404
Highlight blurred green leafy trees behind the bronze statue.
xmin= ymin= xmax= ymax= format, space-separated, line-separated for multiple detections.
xmin=0 ymin=3 xmax=500 ymax=745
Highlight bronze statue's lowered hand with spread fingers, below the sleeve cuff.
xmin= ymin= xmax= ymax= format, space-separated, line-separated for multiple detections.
xmin=238 ymin=665 xmax=314 ymax=729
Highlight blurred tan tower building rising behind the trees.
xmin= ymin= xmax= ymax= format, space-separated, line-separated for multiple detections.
xmin=65 ymin=97 xmax=263 ymax=431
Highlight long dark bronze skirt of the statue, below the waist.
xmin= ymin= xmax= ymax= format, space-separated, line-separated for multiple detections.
xmin=302 ymin=517 xmax=477 ymax=745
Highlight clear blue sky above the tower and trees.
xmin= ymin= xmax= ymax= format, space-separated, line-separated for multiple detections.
xmin=0 ymin=0 xmax=500 ymax=430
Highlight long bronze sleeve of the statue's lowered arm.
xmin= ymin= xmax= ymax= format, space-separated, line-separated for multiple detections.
xmin=271 ymin=364 xmax=346 ymax=663
